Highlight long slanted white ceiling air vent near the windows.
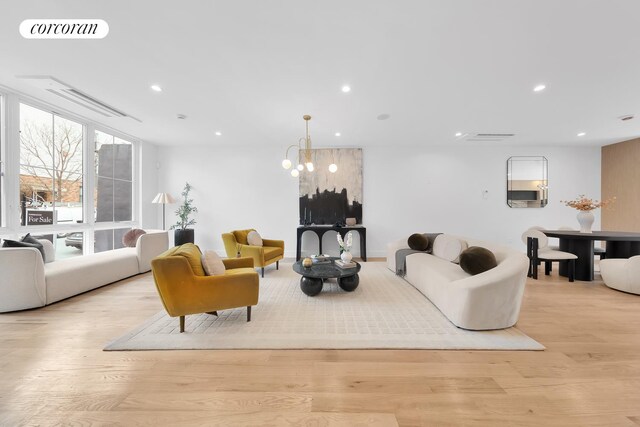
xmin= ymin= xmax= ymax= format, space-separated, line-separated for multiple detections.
xmin=17 ymin=76 xmax=142 ymax=123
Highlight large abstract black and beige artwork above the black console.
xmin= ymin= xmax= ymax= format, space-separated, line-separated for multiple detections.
xmin=300 ymin=148 xmax=362 ymax=224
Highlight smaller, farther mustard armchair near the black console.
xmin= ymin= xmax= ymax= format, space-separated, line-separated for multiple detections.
xmin=222 ymin=228 xmax=284 ymax=277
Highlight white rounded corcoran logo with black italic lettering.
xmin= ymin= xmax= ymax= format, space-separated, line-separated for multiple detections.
xmin=20 ymin=19 xmax=109 ymax=39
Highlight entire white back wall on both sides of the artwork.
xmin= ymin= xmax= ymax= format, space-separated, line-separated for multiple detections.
xmin=158 ymin=146 xmax=600 ymax=257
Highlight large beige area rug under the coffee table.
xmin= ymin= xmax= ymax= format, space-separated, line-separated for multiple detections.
xmin=105 ymin=262 xmax=544 ymax=350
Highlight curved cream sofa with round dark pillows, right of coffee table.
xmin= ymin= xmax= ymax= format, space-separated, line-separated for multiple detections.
xmin=387 ymin=235 xmax=529 ymax=330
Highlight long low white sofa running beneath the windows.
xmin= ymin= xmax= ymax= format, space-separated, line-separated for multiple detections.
xmin=0 ymin=231 xmax=169 ymax=313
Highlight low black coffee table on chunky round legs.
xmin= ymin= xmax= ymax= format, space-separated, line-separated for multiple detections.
xmin=293 ymin=258 xmax=360 ymax=297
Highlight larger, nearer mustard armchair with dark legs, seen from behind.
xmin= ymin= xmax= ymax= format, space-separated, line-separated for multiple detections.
xmin=151 ymin=243 xmax=260 ymax=332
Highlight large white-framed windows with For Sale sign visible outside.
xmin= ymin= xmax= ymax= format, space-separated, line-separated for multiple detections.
xmin=0 ymin=94 xmax=139 ymax=259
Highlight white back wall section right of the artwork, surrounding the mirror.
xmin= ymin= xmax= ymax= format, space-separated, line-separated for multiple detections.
xmin=364 ymin=146 xmax=600 ymax=256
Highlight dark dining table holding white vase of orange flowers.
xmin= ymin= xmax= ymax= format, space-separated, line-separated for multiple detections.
xmin=541 ymin=230 xmax=640 ymax=281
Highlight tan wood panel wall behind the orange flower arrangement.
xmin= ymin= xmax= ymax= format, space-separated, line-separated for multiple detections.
xmin=601 ymin=138 xmax=640 ymax=232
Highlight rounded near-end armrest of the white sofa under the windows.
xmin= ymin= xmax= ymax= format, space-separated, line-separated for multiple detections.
xmin=0 ymin=248 xmax=47 ymax=313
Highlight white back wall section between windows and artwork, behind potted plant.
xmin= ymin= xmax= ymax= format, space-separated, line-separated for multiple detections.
xmin=158 ymin=147 xmax=298 ymax=255
